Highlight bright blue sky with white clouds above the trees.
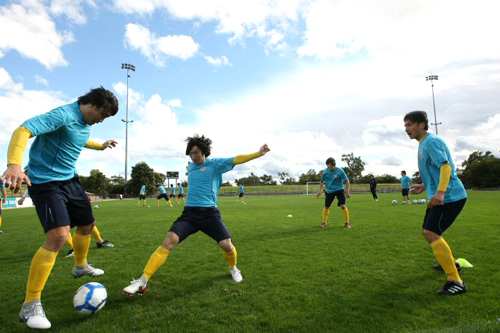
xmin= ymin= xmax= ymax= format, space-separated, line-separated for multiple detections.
xmin=0 ymin=0 xmax=500 ymax=180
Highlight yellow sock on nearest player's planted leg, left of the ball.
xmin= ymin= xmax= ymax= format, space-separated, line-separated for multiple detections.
xmin=24 ymin=247 xmax=58 ymax=303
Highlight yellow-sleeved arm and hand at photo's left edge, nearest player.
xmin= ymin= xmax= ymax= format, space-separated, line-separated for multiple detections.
xmin=0 ymin=126 xmax=32 ymax=193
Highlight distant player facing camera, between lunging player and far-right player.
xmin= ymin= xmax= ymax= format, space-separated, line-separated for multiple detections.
xmin=316 ymin=157 xmax=351 ymax=229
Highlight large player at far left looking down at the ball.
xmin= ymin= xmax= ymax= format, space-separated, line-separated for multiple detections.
xmin=1 ymin=87 xmax=118 ymax=329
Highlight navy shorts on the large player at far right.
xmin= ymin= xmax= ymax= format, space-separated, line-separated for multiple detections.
xmin=422 ymin=198 xmax=467 ymax=235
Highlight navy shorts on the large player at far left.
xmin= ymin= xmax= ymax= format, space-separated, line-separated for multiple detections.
xmin=28 ymin=176 xmax=95 ymax=233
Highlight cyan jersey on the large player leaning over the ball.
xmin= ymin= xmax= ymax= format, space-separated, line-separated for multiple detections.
xmin=22 ymin=102 xmax=91 ymax=184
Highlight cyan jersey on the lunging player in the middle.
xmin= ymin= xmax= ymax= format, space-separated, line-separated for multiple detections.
xmin=186 ymin=157 xmax=234 ymax=207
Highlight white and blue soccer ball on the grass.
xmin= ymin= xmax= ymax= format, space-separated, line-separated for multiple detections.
xmin=73 ymin=282 xmax=108 ymax=315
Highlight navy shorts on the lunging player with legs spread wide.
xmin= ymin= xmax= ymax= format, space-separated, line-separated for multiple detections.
xmin=169 ymin=207 xmax=231 ymax=243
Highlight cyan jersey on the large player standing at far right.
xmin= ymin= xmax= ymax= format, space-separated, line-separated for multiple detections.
xmin=418 ymin=133 xmax=467 ymax=203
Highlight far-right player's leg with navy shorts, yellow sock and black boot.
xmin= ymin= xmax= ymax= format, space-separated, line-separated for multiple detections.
xmin=422 ymin=199 xmax=467 ymax=295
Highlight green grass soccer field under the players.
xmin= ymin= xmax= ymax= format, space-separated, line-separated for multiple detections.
xmin=0 ymin=192 xmax=500 ymax=332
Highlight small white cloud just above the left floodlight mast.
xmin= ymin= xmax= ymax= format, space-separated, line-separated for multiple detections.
xmin=125 ymin=23 xmax=199 ymax=66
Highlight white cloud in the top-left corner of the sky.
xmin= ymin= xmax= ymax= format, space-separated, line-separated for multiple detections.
xmin=0 ymin=0 xmax=74 ymax=69
